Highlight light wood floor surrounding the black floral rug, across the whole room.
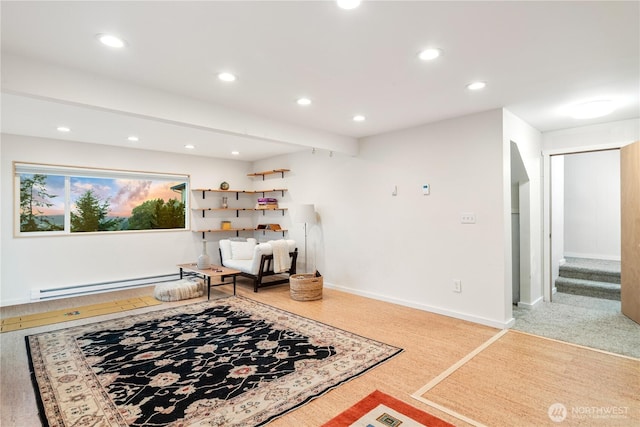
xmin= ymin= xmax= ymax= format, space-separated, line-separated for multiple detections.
xmin=0 ymin=280 xmax=640 ymax=427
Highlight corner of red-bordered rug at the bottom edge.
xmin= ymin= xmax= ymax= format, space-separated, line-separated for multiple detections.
xmin=322 ymin=390 xmax=453 ymax=427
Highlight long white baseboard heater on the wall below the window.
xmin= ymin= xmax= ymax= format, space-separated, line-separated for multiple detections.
xmin=31 ymin=273 xmax=180 ymax=301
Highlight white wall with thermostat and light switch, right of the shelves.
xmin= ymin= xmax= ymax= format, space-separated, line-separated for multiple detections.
xmin=254 ymin=110 xmax=511 ymax=326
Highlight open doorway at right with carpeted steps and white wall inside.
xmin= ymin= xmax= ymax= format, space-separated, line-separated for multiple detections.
xmin=550 ymin=149 xmax=621 ymax=312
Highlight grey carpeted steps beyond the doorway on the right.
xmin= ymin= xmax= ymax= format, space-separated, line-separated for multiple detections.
xmin=556 ymin=257 xmax=620 ymax=301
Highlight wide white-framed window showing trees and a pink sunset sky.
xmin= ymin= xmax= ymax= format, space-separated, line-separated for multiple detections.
xmin=14 ymin=163 xmax=189 ymax=235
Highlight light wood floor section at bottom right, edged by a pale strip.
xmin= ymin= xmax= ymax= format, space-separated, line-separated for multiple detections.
xmin=422 ymin=331 xmax=640 ymax=426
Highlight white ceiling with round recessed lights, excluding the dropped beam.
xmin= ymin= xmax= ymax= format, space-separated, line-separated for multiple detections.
xmin=1 ymin=0 xmax=640 ymax=161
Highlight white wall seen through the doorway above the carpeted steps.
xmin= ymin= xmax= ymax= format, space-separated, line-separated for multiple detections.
xmin=564 ymin=150 xmax=620 ymax=261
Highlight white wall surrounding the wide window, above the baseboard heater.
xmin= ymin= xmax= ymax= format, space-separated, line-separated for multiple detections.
xmin=0 ymin=134 xmax=253 ymax=305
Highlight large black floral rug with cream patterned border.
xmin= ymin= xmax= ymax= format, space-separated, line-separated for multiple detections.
xmin=26 ymin=297 xmax=402 ymax=427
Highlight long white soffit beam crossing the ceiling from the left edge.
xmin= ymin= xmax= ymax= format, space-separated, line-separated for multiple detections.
xmin=2 ymin=55 xmax=358 ymax=156
